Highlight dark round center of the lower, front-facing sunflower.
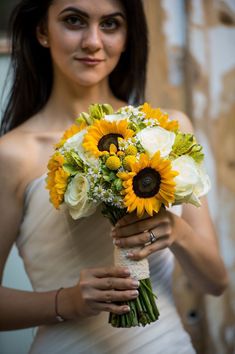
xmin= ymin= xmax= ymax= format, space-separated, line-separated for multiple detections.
xmin=133 ymin=167 xmax=161 ymax=198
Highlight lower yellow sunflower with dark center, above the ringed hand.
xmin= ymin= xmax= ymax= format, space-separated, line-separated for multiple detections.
xmin=117 ymin=151 xmax=178 ymax=217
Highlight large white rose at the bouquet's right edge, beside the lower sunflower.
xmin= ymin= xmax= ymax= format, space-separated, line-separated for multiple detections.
xmin=172 ymin=155 xmax=210 ymax=206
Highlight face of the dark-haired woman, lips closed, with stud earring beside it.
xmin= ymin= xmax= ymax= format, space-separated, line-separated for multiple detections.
xmin=39 ymin=0 xmax=127 ymax=86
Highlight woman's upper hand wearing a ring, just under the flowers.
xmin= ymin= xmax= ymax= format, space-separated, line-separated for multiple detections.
xmin=112 ymin=209 xmax=179 ymax=260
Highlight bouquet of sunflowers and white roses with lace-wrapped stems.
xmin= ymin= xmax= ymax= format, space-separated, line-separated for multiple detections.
xmin=47 ymin=103 xmax=210 ymax=327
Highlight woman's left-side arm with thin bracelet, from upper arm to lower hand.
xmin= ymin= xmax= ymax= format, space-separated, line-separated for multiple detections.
xmin=0 ymin=135 xmax=138 ymax=331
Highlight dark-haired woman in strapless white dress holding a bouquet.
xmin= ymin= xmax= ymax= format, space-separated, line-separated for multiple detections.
xmin=0 ymin=0 xmax=227 ymax=354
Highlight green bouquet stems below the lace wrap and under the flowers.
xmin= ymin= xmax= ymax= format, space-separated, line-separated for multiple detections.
xmin=102 ymin=204 xmax=159 ymax=328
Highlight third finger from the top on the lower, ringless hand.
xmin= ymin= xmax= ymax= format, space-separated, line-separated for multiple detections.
xmin=93 ymin=290 xmax=139 ymax=303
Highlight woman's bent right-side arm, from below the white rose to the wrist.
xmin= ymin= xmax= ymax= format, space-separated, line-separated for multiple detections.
xmin=170 ymin=198 xmax=228 ymax=295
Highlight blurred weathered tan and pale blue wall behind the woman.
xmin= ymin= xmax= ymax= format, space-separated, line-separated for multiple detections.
xmin=0 ymin=0 xmax=235 ymax=354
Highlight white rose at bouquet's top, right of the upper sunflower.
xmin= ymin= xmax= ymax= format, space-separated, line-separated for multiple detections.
xmin=136 ymin=127 xmax=175 ymax=157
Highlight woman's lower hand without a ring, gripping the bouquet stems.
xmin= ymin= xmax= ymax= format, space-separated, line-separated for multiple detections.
xmin=67 ymin=267 xmax=139 ymax=319
